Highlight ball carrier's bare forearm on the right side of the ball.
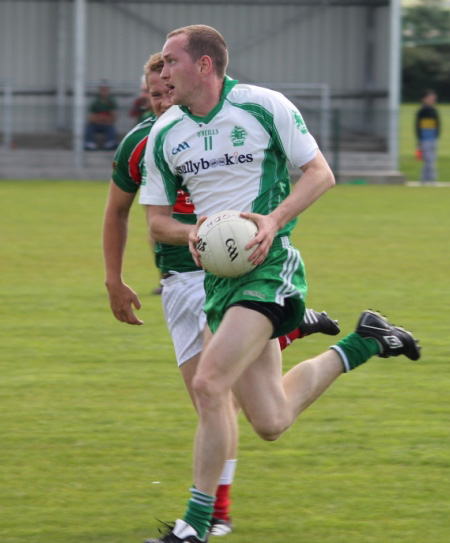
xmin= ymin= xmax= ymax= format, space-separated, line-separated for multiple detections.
xmin=270 ymin=153 xmax=335 ymax=230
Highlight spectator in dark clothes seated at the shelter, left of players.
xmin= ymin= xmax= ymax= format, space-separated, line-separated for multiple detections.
xmin=85 ymin=81 xmax=117 ymax=151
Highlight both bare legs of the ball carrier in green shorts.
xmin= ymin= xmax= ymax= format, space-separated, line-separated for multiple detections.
xmin=194 ymin=307 xmax=343 ymax=495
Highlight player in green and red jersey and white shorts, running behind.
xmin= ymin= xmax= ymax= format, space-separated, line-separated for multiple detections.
xmin=103 ymin=54 xmax=339 ymax=535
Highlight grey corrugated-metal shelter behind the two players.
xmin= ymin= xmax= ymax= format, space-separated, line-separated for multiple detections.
xmin=0 ymin=0 xmax=401 ymax=183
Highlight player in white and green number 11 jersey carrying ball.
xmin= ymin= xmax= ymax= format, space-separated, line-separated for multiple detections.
xmin=140 ymin=25 xmax=420 ymax=543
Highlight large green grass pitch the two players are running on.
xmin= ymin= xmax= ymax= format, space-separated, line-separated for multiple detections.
xmin=0 ymin=182 xmax=450 ymax=543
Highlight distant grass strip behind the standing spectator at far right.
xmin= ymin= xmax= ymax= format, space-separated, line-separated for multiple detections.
xmin=399 ymin=104 xmax=450 ymax=182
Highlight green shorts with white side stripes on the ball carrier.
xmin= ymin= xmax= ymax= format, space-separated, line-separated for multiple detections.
xmin=204 ymin=236 xmax=307 ymax=338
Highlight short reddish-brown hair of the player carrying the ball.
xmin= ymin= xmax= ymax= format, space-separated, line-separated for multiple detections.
xmin=167 ymin=25 xmax=228 ymax=77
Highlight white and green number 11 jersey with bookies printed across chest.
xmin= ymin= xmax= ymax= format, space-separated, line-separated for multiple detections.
xmin=139 ymin=77 xmax=317 ymax=235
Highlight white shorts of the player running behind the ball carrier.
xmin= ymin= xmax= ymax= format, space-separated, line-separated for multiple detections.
xmin=161 ymin=270 xmax=206 ymax=366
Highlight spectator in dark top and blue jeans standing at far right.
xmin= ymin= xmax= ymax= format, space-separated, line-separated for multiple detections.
xmin=415 ymin=89 xmax=440 ymax=183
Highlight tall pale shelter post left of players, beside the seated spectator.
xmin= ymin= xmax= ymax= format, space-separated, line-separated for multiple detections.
xmin=73 ymin=0 xmax=86 ymax=169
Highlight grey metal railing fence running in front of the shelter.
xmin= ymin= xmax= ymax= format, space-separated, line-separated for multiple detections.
xmin=0 ymin=81 xmax=404 ymax=182
